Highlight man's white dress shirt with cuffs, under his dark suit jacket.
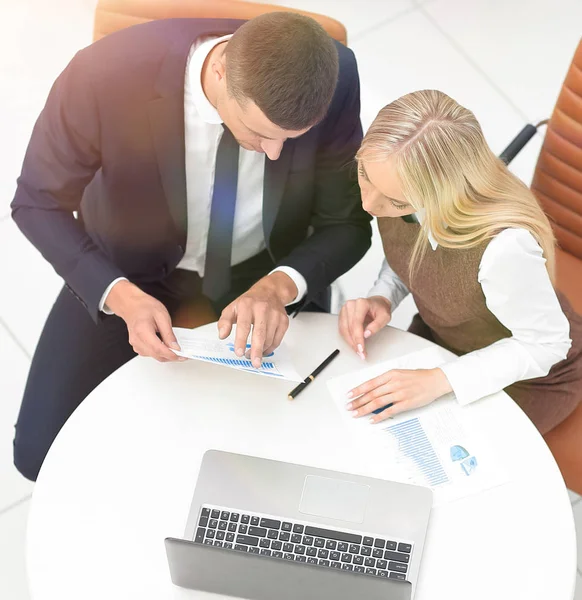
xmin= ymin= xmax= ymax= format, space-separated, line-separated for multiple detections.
xmin=99 ymin=35 xmax=307 ymax=314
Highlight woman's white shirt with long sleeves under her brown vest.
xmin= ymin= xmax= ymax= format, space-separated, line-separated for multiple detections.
xmin=368 ymin=215 xmax=572 ymax=405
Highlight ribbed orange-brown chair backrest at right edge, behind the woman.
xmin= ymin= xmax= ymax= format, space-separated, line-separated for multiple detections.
xmin=531 ymin=41 xmax=582 ymax=259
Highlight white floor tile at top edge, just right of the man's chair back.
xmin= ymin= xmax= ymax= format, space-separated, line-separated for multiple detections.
xmin=253 ymin=0 xmax=414 ymax=39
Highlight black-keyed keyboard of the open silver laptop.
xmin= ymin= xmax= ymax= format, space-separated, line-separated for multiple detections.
xmin=194 ymin=505 xmax=413 ymax=580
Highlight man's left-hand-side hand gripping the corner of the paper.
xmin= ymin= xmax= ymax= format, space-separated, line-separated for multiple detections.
xmin=106 ymin=281 xmax=186 ymax=362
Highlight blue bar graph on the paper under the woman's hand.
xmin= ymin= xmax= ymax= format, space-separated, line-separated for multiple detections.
xmin=385 ymin=419 xmax=449 ymax=486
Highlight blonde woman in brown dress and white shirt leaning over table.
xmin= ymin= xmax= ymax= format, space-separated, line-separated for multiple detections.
xmin=340 ymin=90 xmax=582 ymax=493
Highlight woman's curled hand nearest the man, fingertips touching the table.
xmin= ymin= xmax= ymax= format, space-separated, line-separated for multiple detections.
xmin=339 ymin=296 xmax=392 ymax=360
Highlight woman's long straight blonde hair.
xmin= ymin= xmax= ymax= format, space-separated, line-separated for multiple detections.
xmin=357 ymin=90 xmax=555 ymax=281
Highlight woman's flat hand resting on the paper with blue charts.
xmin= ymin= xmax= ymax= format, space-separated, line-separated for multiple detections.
xmin=346 ymin=368 xmax=452 ymax=423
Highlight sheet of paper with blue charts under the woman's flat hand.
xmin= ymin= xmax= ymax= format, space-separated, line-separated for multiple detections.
xmin=327 ymin=348 xmax=508 ymax=505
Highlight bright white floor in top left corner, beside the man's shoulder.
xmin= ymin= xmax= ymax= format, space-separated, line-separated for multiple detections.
xmin=0 ymin=0 xmax=96 ymax=216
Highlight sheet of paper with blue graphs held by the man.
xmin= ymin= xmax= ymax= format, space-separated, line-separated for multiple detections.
xmin=174 ymin=327 xmax=302 ymax=381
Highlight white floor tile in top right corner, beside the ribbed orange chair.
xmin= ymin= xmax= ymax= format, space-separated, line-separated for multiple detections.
xmin=424 ymin=0 xmax=582 ymax=119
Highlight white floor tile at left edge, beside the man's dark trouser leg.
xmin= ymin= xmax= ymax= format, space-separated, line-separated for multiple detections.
xmin=0 ymin=323 xmax=32 ymax=508
